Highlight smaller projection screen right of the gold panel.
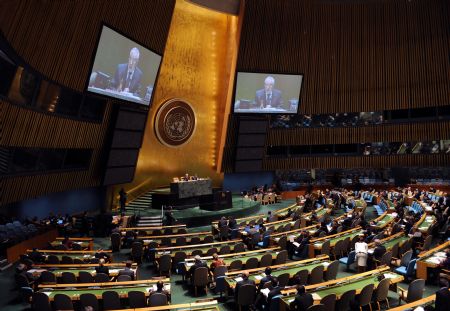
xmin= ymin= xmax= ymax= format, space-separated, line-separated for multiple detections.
xmin=234 ymin=72 xmax=303 ymax=114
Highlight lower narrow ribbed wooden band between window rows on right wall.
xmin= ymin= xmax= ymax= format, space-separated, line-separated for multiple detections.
xmin=263 ymin=154 xmax=450 ymax=171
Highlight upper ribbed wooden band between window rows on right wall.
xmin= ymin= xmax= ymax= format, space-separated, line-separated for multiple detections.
xmin=267 ymin=121 xmax=450 ymax=146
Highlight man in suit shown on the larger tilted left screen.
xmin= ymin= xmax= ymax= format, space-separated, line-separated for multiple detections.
xmin=112 ymin=47 xmax=142 ymax=97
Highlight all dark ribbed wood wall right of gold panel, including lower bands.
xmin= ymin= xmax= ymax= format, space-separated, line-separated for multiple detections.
xmin=223 ymin=0 xmax=450 ymax=172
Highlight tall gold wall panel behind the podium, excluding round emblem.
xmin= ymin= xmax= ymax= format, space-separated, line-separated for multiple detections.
xmin=126 ymin=0 xmax=238 ymax=197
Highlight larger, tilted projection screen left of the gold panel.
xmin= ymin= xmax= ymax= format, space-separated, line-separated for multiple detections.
xmin=87 ymin=25 xmax=161 ymax=106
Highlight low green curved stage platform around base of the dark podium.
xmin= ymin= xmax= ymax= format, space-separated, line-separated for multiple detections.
xmin=127 ymin=194 xmax=295 ymax=227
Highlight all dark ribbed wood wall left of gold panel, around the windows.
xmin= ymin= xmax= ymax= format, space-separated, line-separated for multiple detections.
xmin=0 ymin=0 xmax=175 ymax=205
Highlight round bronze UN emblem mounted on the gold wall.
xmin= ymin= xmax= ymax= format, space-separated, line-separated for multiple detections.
xmin=155 ymin=99 xmax=196 ymax=147
